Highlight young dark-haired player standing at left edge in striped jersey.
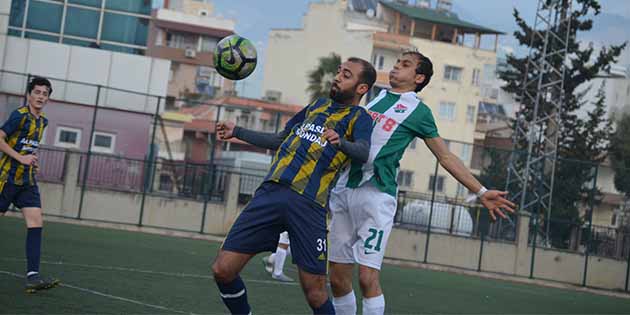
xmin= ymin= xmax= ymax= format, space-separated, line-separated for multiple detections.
xmin=0 ymin=77 xmax=59 ymax=293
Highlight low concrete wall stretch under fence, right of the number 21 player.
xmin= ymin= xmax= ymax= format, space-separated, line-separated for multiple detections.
xmin=385 ymin=216 xmax=627 ymax=289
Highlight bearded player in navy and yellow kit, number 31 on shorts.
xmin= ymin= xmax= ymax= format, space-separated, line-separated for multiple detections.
xmin=212 ymin=58 xmax=376 ymax=314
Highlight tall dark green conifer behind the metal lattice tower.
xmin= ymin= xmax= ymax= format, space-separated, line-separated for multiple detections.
xmin=499 ymin=0 xmax=626 ymax=246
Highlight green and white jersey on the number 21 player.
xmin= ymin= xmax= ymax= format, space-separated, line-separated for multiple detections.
xmin=337 ymin=90 xmax=439 ymax=197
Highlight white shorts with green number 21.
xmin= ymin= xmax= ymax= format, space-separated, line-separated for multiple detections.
xmin=328 ymin=182 xmax=396 ymax=270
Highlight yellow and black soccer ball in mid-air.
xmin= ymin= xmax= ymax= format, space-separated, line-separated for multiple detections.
xmin=214 ymin=35 xmax=258 ymax=80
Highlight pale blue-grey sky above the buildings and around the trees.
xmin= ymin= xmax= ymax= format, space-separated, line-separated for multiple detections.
xmin=156 ymin=0 xmax=630 ymax=98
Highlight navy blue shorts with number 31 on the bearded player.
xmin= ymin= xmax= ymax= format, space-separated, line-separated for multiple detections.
xmin=222 ymin=182 xmax=328 ymax=275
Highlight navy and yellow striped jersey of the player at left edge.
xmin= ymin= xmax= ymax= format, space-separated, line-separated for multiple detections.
xmin=0 ymin=106 xmax=48 ymax=186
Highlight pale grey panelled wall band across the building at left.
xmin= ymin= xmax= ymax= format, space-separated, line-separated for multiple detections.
xmin=0 ymin=35 xmax=170 ymax=113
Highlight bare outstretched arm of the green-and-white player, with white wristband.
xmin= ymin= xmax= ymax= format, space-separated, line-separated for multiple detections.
xmin=424 ymin=137 xmax=516 ymax=220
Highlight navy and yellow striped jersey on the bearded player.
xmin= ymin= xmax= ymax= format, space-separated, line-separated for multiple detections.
xmin=265 ymin=98 xmax=373 ymax=207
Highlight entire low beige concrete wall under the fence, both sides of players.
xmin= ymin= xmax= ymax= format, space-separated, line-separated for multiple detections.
xmin=35 ymin=153 xmax=627 ymax=289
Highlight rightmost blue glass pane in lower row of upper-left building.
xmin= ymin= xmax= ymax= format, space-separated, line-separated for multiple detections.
xmin=101 ymin=12 xmax=149 ymax=46
